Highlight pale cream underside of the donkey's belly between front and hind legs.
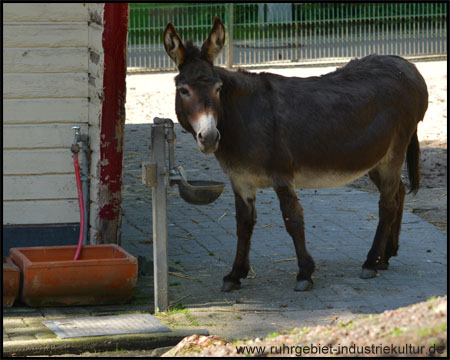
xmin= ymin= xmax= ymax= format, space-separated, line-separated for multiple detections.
xmin=294 ymin=169 xmax=370 ymax=189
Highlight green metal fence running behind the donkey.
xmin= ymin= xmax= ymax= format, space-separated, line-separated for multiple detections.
xmin=128 ymin=2 xmax=447 ymax=71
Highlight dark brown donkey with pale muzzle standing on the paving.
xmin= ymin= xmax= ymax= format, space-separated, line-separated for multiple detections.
xmin=164 ymin=16 xmax=428 ymax=291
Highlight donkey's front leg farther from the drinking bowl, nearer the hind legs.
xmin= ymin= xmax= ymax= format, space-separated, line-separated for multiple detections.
xmin=274 ymin=183 xmax=315 ymax=291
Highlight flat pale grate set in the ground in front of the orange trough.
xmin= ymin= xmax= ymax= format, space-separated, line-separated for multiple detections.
xmin=42 ymin=314 xmax=171 ymax=339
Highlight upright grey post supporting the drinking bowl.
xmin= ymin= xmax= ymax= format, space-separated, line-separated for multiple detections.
xmin=152 ymin=125 xmax=169 ymax=313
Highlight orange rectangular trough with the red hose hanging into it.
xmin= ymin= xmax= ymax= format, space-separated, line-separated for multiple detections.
xmin=10 ymin=244 xmax=138 ymax=307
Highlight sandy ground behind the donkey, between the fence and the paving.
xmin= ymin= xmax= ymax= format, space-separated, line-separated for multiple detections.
xmin=125 ymin=61 xmax=447 ymax=231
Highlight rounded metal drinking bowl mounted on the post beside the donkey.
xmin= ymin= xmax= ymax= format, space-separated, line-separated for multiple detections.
xmin=178 ymin=179 xmax=225 ymax=205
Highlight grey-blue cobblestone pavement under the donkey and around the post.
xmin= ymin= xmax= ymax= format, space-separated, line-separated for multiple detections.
xmin=121 ymin=119 xmax=447 ymax=339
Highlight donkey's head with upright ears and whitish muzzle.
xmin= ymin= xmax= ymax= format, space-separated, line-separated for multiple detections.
xmin=164 ymin=16 xmax=225 ymax=154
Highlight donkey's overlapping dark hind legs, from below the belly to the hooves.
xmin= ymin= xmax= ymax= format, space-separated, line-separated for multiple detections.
xmin=361 ymin=163 xmax=405 ymax=279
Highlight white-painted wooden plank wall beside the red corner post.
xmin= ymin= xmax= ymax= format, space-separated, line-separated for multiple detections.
xmin=3 ymin=3 xmax=104 ymax=242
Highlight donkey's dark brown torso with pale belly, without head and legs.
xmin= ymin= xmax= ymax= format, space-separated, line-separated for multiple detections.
xmin=216 ymin=55 xmax=428 ymax=188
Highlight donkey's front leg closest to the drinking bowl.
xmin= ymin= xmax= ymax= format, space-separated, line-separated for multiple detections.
xmin=222 ymin=181 xmax=256 ymax=291
